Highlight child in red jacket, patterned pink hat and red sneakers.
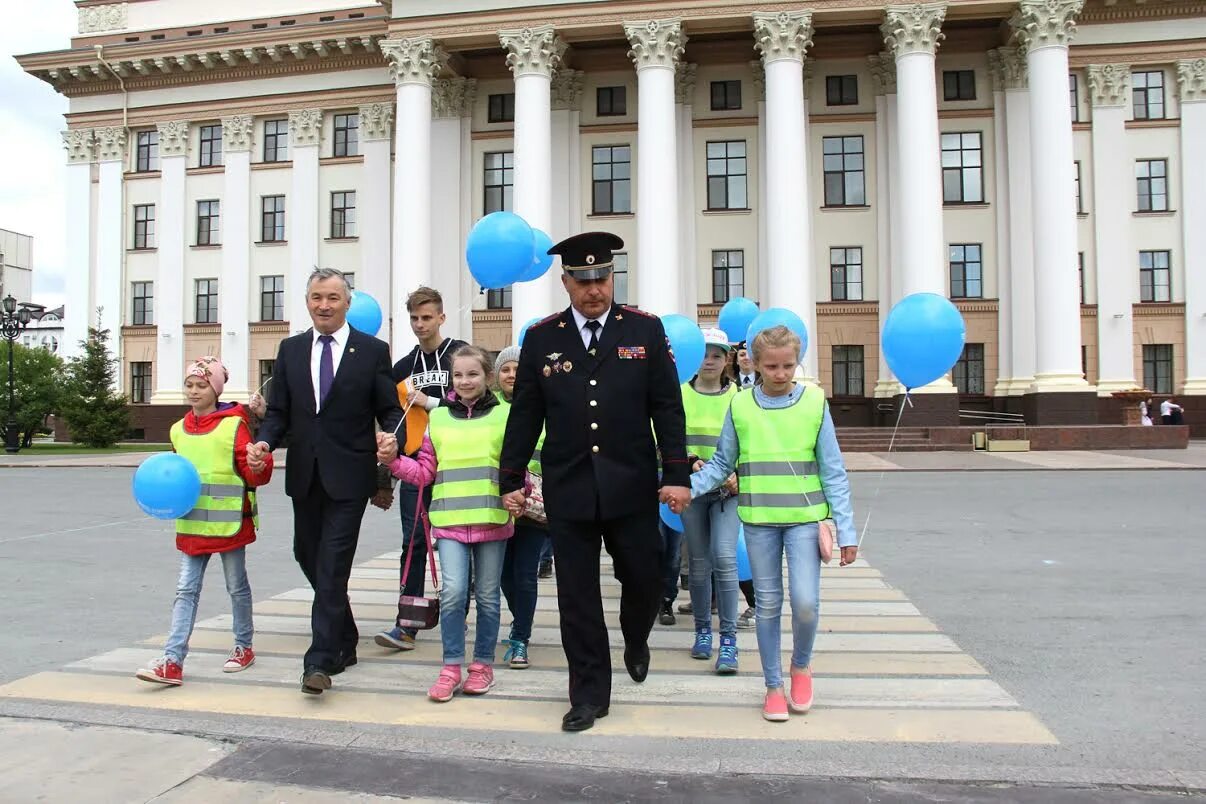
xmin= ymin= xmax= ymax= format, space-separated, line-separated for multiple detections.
xmin=135 ymin=357 xmax=273 ymax=686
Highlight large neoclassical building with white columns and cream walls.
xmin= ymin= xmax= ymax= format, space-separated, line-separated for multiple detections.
xmin=19 ymin=0 xmax=1206 ymax=424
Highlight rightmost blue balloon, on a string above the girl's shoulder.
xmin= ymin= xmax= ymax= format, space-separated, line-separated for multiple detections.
xmin=880 ymin=293 xmax=967 ymax=389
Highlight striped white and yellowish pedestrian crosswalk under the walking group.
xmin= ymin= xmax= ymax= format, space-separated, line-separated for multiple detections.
xmin=0 ymin=552 xmax=1056 ymax=744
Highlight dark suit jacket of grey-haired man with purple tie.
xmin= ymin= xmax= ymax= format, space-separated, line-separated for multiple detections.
xmin=258 ymin=329 xmax=402 ymax=500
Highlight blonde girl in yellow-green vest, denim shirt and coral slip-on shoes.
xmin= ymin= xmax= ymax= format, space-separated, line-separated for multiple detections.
xmin=691 ymin=325 xmax=859 ymax=721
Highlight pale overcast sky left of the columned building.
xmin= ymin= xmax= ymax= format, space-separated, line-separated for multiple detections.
xmin=0 ymin=0 xmax=76 ymax=307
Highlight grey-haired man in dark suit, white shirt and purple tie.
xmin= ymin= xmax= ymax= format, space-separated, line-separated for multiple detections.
xmin=247 ymin=269 xmax=402 ymax=694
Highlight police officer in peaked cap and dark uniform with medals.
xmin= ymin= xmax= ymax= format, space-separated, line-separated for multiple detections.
xmin=499 ymin=231 xmax=690 ymax=732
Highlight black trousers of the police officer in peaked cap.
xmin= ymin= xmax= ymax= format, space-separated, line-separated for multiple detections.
xmin=549 ymin=506 xmax=662 ymax=706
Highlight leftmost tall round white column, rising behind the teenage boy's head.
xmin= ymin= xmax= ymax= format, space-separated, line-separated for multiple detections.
xmin=380 ymin=36 xmax=447 ymax=354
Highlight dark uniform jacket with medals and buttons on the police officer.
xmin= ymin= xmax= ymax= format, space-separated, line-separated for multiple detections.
xmin=499 ymin=305 xmax=690 ymax=520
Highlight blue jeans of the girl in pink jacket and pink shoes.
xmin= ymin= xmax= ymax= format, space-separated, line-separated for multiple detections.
xmin=436 ymin=539 xmax=507 ymax=664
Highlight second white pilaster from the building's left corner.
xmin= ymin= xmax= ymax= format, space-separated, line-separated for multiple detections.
xmin=88 ymin=125 xmax=131 ymax=391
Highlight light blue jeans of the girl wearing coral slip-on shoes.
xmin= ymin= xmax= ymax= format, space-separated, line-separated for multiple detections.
xmin=745 ymin=522 xmax=821 ymax=688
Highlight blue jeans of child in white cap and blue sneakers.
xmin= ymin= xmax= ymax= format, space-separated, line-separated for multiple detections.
xmin=683 ymin=494 xmax=737 ymax=634
